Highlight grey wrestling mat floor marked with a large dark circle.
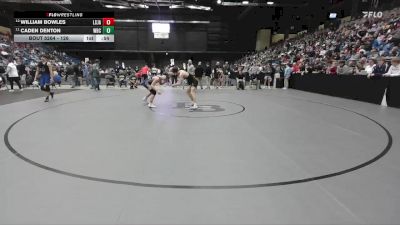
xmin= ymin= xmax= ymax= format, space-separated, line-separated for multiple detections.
xmin=0 ymin=88 xmax=400 ymax=224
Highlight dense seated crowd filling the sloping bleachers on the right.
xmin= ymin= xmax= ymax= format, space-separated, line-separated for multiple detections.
xmin=234 ymin=8 xmax=400 ymax=82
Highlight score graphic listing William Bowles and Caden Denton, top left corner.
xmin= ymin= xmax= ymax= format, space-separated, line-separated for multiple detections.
xmin=13 ymin=12 xmax=115 ymax=42
